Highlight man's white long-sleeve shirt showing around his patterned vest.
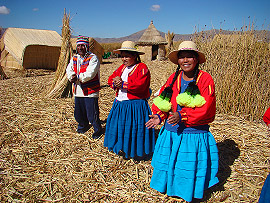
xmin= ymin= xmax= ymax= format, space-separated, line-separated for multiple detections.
xmin=66 ymin=53 xmax=100 ymax=97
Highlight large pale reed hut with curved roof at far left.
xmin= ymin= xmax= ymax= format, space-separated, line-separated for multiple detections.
xmin=0 ymin=28 xmax=61 ymax=70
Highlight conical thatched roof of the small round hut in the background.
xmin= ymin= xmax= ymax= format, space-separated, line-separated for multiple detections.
xmin=137 ymin=21 xmax=167 ymax=45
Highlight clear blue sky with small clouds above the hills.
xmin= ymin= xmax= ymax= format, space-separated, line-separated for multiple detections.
xmin=0 ymin=0 xmax=270 ymax=38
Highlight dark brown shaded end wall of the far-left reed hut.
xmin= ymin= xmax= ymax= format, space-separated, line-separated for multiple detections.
xmin=23 ymin=45 xmax=60 ymax=70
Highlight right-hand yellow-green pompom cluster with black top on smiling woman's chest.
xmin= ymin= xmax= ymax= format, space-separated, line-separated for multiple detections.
xmin=176 ymin=82 xmax=206 ymax=108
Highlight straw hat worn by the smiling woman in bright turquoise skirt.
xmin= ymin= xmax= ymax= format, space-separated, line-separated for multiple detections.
xmin=168 ymin=41 xmax=206 ymax=64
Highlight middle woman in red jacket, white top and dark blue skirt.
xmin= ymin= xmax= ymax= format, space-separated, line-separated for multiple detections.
xmin=104 ymin=41 xmax=155 ymax=159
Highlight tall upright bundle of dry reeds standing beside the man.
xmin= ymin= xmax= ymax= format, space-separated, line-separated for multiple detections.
xmin=47 ymin=10 xmax=72 ymax=98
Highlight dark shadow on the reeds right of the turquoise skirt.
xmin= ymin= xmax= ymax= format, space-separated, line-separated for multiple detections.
xmin=202 ymin=139 xmax=240 ymax=201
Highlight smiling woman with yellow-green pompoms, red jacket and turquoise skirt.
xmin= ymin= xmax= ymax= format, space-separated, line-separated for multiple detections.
xmin=146 ymin=41 xmax=218 ymax=202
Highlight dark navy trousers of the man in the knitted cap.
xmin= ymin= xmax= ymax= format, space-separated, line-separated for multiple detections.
xmin=74 ymin=97 xmax=101 ymax=133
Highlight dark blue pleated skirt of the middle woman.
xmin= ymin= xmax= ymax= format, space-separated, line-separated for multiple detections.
xmin=104 ymin=99 xmax=155 ymax=158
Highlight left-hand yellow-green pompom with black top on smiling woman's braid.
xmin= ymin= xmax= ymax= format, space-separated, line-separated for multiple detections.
xmin=153 ymin=87 xmax=173 ymax=112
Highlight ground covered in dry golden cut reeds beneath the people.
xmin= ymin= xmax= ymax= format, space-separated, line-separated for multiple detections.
xmin=0 ymin=59 xmax=269 ymax=202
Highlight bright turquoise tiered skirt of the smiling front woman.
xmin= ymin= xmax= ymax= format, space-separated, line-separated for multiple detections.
xmin=150 ymin=127 xmax=218 ymax=202
